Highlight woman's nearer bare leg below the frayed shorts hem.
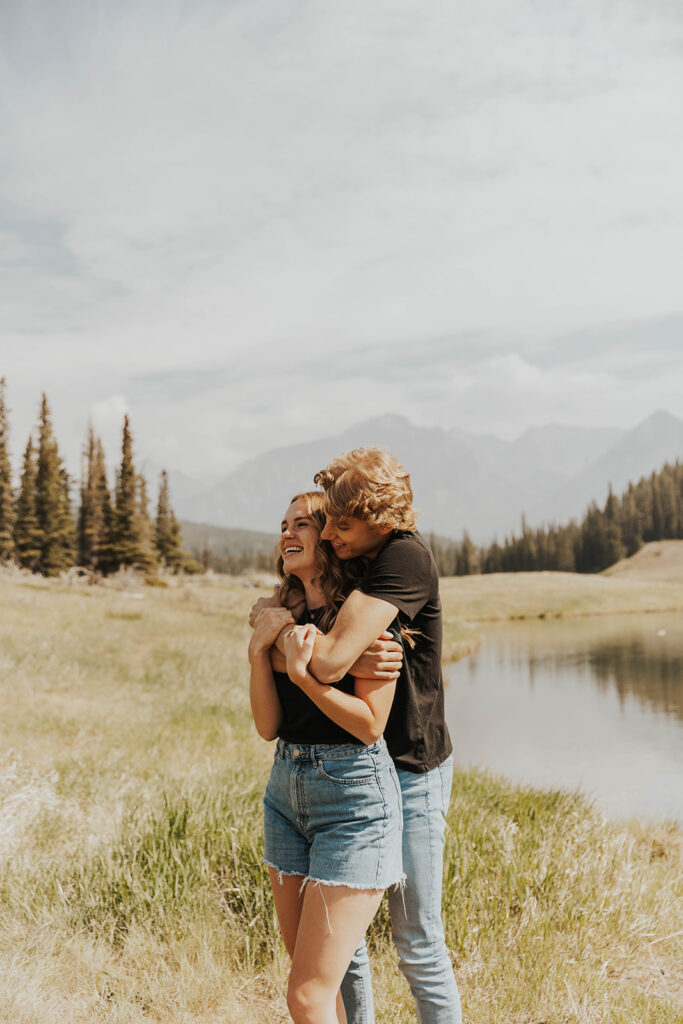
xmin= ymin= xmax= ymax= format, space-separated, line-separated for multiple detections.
xmin=287 ymin=882 xmax=382 ymax=1024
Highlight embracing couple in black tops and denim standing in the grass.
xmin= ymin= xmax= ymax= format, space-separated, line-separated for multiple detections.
xmin=249 ymin=449 xmax=461 ymax=1024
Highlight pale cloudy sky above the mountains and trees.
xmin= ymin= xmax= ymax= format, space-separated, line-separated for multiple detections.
xmin=0 ymin=0 xmax=683 ymax=475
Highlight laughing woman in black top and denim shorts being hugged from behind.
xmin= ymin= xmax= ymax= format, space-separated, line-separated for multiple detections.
xmin=249 ymin=492 xmax=402 ymax=1024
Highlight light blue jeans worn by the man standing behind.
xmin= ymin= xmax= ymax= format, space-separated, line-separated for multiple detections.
xmin=341 ymin=758 xmax=462 ymax=1024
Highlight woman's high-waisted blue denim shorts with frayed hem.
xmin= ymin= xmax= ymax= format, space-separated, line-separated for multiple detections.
xmin=263 ymin=739 xmax=403 ymax=889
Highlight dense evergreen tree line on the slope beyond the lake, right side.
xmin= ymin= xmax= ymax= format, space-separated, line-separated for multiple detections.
xmin=432 ymin=459 xmax=683 ymax=575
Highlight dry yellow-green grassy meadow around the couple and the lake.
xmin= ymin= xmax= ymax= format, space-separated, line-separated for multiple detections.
xmin=0 ymin=574 xmax=683 ymax=1024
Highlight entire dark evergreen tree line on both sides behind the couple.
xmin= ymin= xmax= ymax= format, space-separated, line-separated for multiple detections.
xmin=0 ymin=378 xmax=683 ymax=575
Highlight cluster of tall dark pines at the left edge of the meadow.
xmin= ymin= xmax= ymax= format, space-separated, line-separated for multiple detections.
xmin=0 ymin=378 xmax=197 ymax=577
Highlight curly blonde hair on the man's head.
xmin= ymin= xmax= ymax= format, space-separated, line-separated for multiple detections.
xmin=313 ymin=449 xmax=418 ymax=530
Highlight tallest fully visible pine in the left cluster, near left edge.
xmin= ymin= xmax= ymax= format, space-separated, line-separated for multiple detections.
xmin=36 ymin=394 xmax=75 ymax=575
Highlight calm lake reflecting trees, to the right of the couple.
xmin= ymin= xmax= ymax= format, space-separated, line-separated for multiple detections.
xmin=445 ymin=612 xmax=683 ymax=821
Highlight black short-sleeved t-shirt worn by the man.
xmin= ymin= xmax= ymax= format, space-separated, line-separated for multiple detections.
xmin=360 ymin=530 xmax=453 ymax=773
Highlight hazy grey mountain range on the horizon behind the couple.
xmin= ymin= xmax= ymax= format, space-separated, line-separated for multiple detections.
xmin=171 ymin=412 xmax=683 ymax=544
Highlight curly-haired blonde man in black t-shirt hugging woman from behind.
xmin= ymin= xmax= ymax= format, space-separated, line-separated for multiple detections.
xmin=255 ymin=449 xmax=462 ymax=1024
